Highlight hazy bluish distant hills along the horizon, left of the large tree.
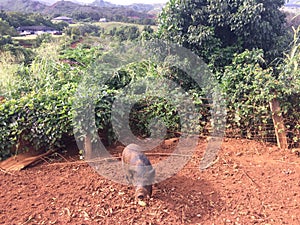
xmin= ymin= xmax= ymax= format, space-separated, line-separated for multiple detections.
xmin=0 ymin=0 xmax=163 ymax=25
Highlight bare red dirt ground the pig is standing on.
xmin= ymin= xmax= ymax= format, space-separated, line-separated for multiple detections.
xmin=0 ymin=139 xmax=300 ymax=225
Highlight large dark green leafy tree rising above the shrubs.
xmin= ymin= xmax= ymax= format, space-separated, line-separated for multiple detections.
xmin=158 ymin=0 xmax=285 ymax=68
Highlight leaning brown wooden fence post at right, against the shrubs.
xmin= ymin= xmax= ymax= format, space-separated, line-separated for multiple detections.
xmin=270 ymin=98 xmax=288 ymax=149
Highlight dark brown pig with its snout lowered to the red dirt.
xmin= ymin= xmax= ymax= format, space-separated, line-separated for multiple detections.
xmin=122 ymin=144 xmax=155 ymax=200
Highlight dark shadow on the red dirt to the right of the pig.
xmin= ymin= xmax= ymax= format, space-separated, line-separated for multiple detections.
xmin=153 ymin=175 xmax=223 ymax=223
